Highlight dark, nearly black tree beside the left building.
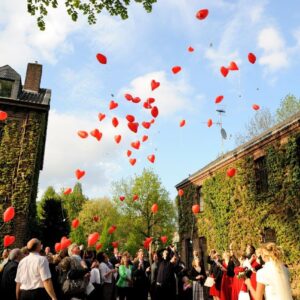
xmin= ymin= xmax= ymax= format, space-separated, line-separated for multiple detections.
xmin=39 ymin=198 xmax=70 ymax=249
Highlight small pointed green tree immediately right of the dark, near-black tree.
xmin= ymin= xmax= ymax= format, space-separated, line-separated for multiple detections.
xmin=61 ymin=182 xmax=88 ymax=222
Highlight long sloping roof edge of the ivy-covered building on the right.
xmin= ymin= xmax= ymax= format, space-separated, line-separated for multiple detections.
xmin=175 ymin=112 xmax=300 ymax=189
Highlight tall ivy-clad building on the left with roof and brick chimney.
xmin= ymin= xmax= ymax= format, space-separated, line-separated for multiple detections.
xmin=0 ymin=63 xmax=51 ymax=247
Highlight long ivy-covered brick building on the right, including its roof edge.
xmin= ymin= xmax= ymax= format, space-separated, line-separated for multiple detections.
xmin=176 ymin=113 xmax=300 ymax=296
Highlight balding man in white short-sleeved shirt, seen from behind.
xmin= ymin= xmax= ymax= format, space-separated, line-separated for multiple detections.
xmin=15 ymin=239 xmax=57 ymax=300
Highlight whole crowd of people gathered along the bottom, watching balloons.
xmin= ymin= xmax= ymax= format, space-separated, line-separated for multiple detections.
xmin=0 ymin=239 xmax=292 ymax=300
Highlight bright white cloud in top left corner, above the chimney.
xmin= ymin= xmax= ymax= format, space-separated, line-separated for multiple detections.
xmin=0 ymin=0 xmax=81 ymax=71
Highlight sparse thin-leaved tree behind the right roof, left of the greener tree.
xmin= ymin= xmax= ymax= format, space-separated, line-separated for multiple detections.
xmin=235 ymin=108 xmax=275 ymax=145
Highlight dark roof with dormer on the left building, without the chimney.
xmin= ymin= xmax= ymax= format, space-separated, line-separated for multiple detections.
xmin=0 ymin=65 xmax=51 ymax=110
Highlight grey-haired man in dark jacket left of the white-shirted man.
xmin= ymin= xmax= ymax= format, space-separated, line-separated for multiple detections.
xmin=1 ymin=249 xmax=23 ymax=300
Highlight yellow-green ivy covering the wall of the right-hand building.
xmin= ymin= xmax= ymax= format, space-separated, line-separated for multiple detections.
xmin=178 ymin=133 xmax=300 ymax=295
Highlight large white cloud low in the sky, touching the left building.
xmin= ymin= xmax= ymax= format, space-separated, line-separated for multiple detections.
xmin=39 ymin=110 xmax=129 ymax=197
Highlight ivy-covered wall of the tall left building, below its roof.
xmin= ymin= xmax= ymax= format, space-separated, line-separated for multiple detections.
xmin=0 ymin=107 xmax=47 ymax=247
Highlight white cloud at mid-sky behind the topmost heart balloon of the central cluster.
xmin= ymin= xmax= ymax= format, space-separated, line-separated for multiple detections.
xmin=120 ymin=71 xmax=193 ymax=117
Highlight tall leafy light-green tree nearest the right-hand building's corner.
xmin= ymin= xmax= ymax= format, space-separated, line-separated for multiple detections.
xmin=113 ymin=169 xmax=176 ymax=251
